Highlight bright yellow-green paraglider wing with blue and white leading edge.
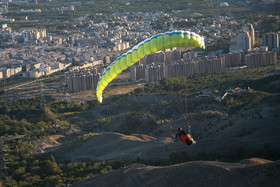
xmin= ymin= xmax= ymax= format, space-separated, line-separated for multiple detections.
xmin=96 ymin=31 xmax=205 ymax=103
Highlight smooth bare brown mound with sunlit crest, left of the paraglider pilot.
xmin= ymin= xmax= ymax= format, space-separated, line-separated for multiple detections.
xmin=57 ymin=132 xmax=179 ymax=161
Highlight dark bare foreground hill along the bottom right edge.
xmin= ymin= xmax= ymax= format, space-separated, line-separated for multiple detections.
xmin=72 ymin=158 xmax=280 ymax=187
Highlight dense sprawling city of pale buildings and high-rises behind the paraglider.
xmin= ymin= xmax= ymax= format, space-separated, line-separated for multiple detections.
xmin=0 ymin=1 xmax=280 ymax=91
